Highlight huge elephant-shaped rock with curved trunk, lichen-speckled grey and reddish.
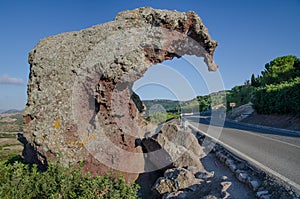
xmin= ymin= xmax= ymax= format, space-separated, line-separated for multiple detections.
xmin=24 ymin=8 xmax=217 ymax=181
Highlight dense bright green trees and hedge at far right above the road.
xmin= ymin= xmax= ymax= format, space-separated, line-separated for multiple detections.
xmin=251 ymin=55 xmax=300 ymax=114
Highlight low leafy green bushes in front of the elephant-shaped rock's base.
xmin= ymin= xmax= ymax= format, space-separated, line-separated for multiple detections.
xmin=0 ymin=158 xmax=139 ymax=199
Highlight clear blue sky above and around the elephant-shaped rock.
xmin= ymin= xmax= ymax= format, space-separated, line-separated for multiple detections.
xmin=0 ymin=0 xmax=300 ymax=109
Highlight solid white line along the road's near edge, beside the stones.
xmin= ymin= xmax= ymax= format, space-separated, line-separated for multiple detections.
xmin=189 ymin=123 xmax=300 ymax=191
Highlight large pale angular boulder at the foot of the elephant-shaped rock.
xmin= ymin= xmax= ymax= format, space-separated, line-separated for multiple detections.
xmin=142 ymin=121 xmax=205 ymax=172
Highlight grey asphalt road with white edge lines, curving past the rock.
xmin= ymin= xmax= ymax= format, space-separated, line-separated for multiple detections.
xmin=185 ymin=116 xmax=300 ymax=192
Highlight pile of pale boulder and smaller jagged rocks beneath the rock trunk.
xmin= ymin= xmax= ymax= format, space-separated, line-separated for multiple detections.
xmin=138 ymin=120 xmax=231 ymax=199
